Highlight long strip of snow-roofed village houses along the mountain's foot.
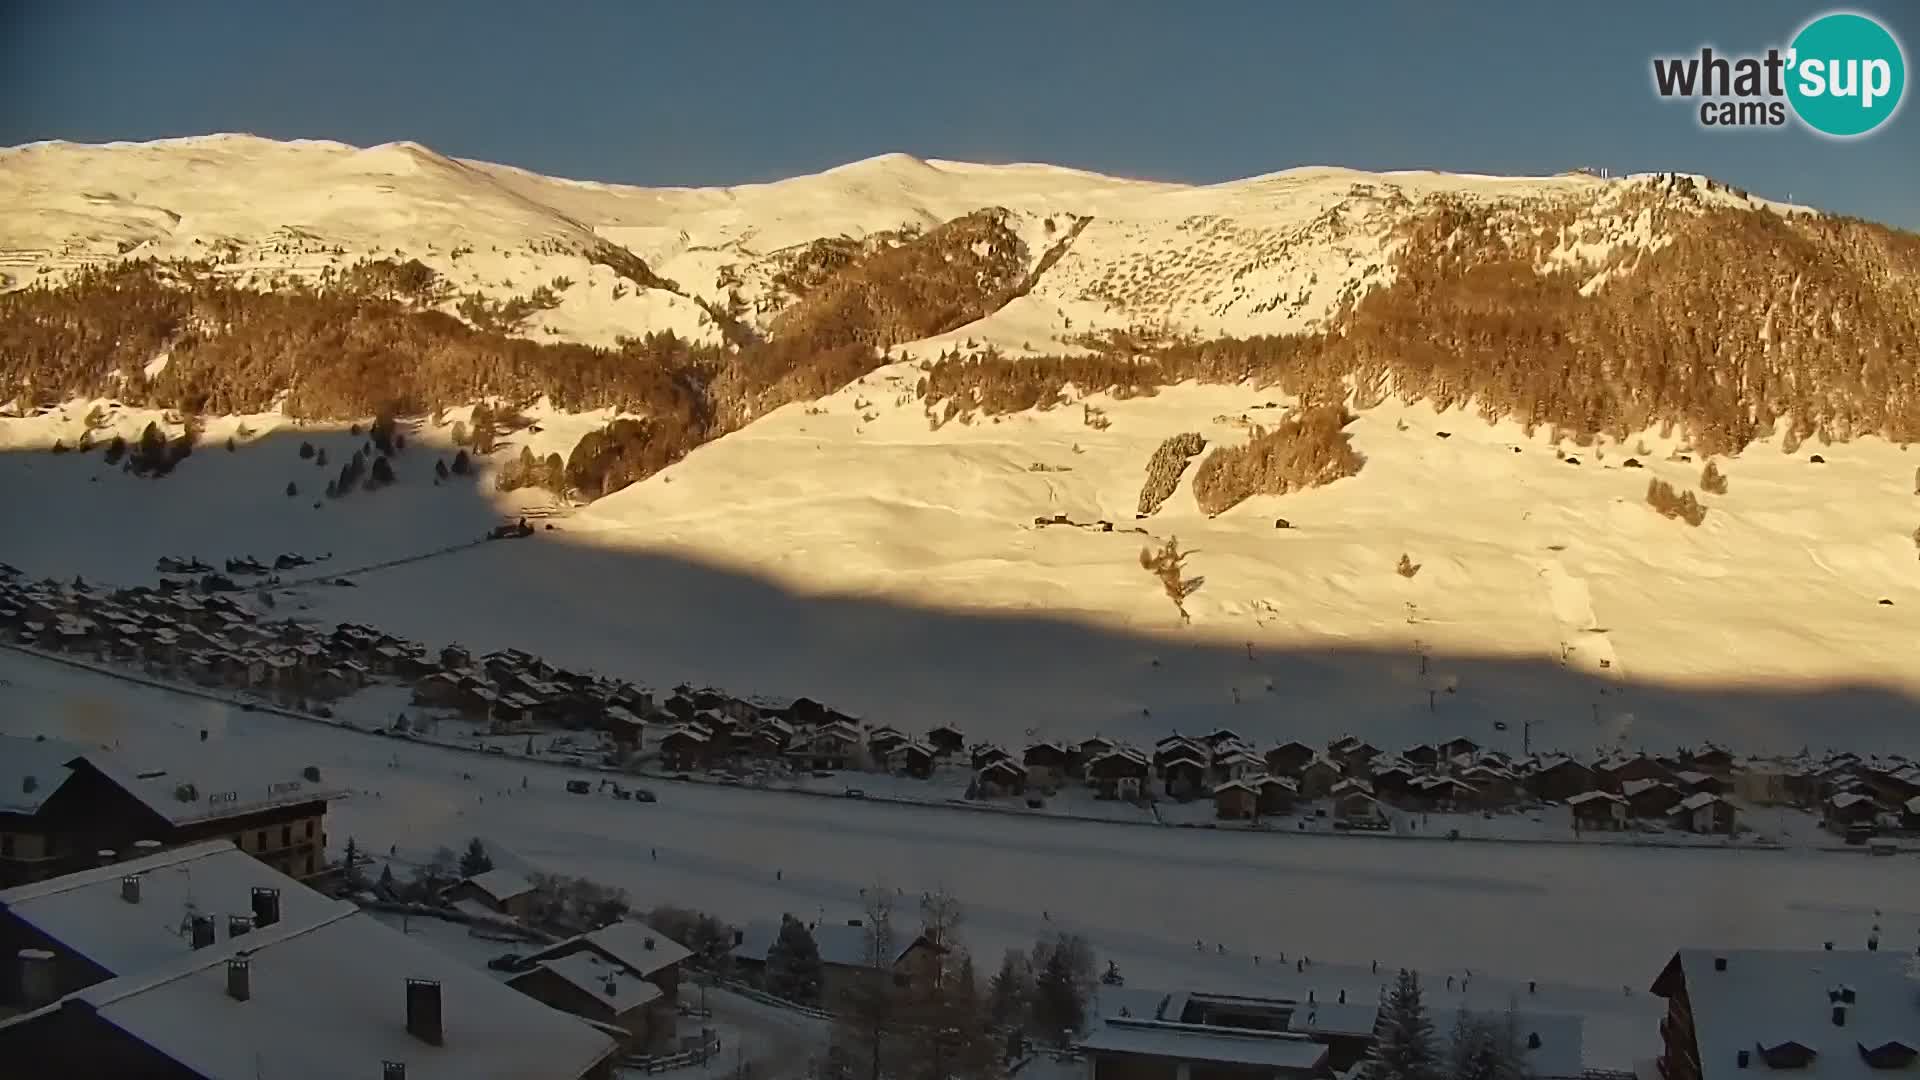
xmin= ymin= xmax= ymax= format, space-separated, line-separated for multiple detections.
xmin=0 ymin=567 xmax=1920 ymax=840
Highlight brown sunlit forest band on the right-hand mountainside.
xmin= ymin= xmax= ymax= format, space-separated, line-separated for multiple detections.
xmin=920 ymin=186 xmax=1920 ymax=454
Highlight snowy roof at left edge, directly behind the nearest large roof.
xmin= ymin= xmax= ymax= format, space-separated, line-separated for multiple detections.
xmin=0 ymin=840 xmax=338 ymax=974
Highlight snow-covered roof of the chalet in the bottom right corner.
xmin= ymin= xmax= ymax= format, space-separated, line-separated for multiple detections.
xmin=1655 ymin=949 xmax=1920 ymax=1080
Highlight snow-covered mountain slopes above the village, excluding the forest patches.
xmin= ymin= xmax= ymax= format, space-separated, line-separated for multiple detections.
xmin=0 ymin=135 xmax=1920 ymax=749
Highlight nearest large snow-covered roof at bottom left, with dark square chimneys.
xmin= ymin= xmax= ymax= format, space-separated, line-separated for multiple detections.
xmin=15 ymin=903 xmax=618 ymax=1080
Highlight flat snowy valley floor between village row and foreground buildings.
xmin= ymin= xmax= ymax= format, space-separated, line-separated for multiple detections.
xmin=0 ymin=641 xmax=1920 ymax=1065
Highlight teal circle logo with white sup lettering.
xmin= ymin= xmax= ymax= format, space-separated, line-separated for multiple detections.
xmin=1788 ymin=12 xmax=1907 ymax=138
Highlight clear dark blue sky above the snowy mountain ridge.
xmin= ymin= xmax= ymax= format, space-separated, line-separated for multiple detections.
xmin=0 ymin=0 xmax=1920 ymax=229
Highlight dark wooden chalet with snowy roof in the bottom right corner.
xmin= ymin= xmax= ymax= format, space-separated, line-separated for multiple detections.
xmin=1653 ymin=949 xmax=1920 ymax=1080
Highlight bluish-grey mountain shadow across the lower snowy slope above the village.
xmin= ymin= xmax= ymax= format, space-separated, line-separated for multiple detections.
xmin=0 ymin=420 xmax=1920 ymax=755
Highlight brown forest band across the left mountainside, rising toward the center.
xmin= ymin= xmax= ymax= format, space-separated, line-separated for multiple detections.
xmin=0 ymin=211 xmax=1025 ymax=496
